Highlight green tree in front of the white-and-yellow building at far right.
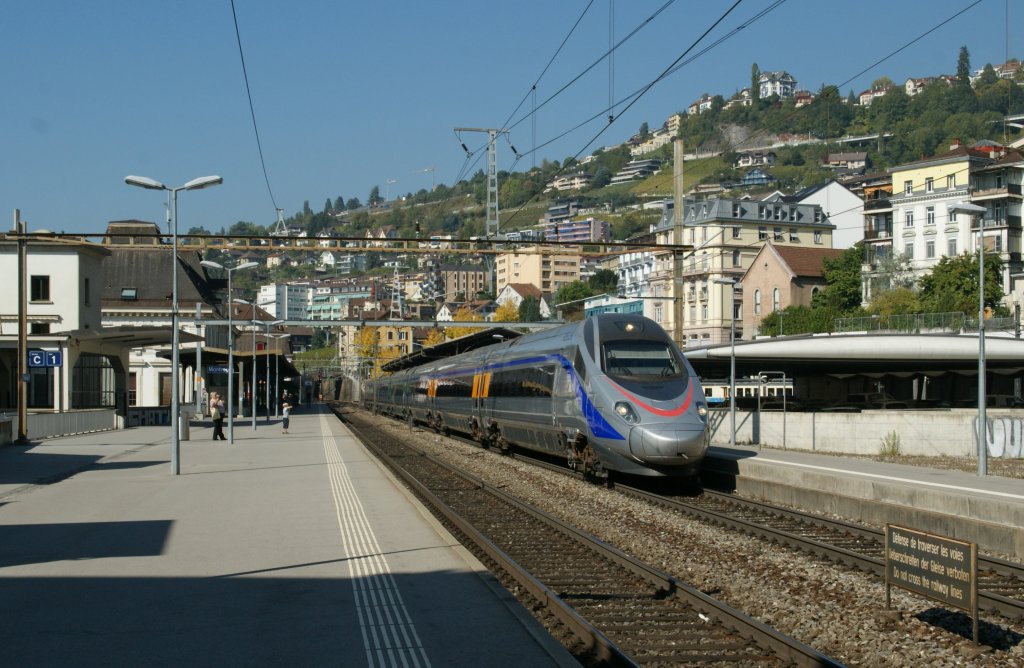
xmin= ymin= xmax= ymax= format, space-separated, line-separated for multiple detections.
xmin=918 ymin=253 xmax=1004 ymax=314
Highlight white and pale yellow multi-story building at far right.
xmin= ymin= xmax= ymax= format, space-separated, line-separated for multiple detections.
xmin=863 ymin=142 xmax=1003 ymax=301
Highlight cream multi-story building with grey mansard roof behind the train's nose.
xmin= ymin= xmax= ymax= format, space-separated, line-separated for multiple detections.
xmin=643 ymin=198 xmax=835 ymax=347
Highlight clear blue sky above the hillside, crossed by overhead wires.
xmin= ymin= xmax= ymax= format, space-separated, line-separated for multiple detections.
xmin=0 ymin=0 xmax=1024 ymax=233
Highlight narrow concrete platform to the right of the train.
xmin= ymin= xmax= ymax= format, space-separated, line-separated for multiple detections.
xmin=701 ymin=445 xmax=1024 ymax=558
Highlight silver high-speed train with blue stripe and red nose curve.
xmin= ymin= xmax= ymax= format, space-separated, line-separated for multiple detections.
xmin=362 ymin=314 xmax=709 ymax=476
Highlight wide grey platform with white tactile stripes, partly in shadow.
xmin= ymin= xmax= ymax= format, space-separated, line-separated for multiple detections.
xmin=0 ymin=406 xmax=578 ymax=668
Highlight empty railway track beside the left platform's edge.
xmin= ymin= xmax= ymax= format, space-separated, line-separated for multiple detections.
xmin=335 ymin=407 xmax=839 ymax=666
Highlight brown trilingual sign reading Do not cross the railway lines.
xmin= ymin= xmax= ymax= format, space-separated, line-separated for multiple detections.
xmin=886 ymin=525 xmax=978 ymax=611
